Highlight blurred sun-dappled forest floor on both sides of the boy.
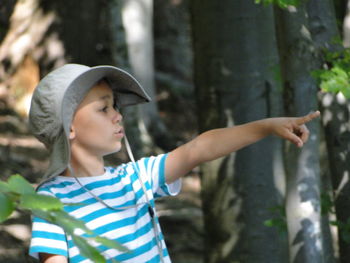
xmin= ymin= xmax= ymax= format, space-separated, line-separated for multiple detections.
xmin=0 ymin=110 xmax=203 ymax=263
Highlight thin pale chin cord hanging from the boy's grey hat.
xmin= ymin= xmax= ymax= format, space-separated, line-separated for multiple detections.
xmin=67 ymin=135 xmax=165 ymax=263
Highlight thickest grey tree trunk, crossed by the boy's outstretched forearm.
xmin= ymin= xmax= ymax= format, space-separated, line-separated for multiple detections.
xmin=191 ymin=0 xmax=286 ymax=263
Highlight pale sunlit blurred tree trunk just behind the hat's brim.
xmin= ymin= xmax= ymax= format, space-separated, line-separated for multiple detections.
xmin=122 ymin=0 xmax=172 ymax=153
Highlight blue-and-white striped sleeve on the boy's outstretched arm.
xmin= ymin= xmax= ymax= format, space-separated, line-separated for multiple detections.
xmin=137 ymin=154 xmax=181 ymax=198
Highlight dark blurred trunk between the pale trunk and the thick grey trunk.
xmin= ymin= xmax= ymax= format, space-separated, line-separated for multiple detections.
xmin=153 ymin=0 xmax=193 ymax=95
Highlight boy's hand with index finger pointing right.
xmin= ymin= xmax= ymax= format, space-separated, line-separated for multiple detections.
xmin=270 ymin=111 xmax=320 ymax=147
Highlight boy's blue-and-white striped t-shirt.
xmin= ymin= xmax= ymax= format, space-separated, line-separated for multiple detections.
xmin=29 ymin=155 xmax=181 ymax=263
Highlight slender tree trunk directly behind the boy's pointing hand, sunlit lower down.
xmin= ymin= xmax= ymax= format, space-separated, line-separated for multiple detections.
xmin=278 ymin=4 xmax=324 ymax=263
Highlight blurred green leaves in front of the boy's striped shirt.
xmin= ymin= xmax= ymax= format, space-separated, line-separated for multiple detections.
xmin=0 ymin=175 xmax=128 ymax=263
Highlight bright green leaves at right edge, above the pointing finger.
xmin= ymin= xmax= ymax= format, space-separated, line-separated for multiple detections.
xmin=312 ymin=49 xmax=350 ymax=99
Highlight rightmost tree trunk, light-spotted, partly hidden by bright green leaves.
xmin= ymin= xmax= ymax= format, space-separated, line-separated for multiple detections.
xmin=309 ymin=0 xmax=350 ymax=263
